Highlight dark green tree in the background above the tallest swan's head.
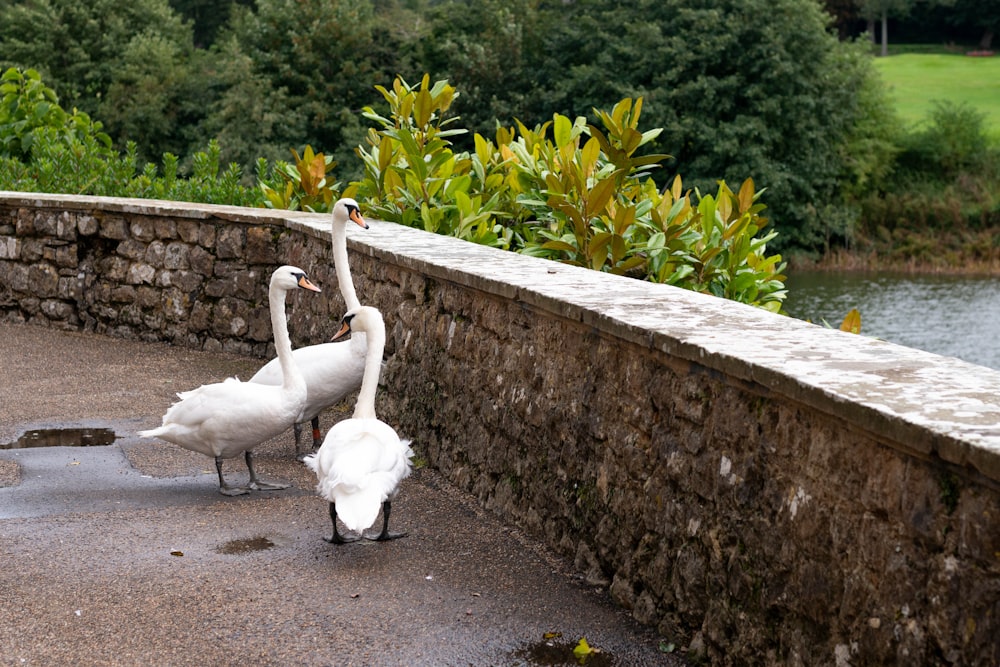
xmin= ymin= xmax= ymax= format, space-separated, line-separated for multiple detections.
xmin=210 ymin=0 xmax=405 ymax=173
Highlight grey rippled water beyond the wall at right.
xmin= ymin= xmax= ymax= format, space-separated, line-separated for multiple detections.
xmin=785 ymin=271 xmax=1000 ymax=369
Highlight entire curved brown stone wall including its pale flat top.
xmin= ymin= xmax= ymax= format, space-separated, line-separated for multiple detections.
xmin=0 ymin=193 xmax=1000 ymax=665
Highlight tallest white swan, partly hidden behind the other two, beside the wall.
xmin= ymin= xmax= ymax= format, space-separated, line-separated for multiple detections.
xmin=250 ymin=197 xmax=368 ymax=460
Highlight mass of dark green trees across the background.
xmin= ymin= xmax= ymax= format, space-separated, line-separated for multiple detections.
xmin=0 ymin=0 xmax=996 ymax=268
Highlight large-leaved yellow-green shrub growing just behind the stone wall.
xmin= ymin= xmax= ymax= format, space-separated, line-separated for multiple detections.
xmin=345 ymin=75 xmax=785 ymax=312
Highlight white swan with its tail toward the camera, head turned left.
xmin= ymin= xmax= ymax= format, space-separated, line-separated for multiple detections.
xmin=305 ymin=306 xmax=413 ymax=544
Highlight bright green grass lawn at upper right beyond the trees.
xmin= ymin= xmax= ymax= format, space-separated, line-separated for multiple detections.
xmin=875 ymin=53 xmax=1000 ymax=140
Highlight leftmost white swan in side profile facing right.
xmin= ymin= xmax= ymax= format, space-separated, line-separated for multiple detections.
xmin=139 ymin=266 xmax=320 ymax=496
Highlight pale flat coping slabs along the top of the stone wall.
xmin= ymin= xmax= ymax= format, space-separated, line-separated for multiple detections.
xmin=7 ymin=191 xmax=1000 ymax=485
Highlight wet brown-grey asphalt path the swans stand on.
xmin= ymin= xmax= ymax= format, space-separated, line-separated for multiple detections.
xmin=0 ymin=324 xmax=684 ymax=666
